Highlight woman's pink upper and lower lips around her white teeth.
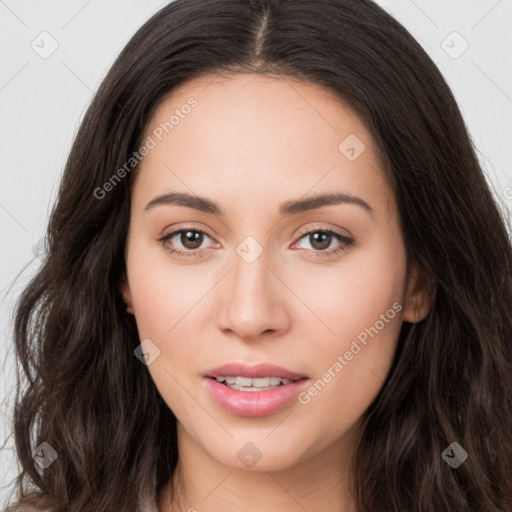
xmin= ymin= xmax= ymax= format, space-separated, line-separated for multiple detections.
xmin=205 ymin=363 xmax=309 ymax=417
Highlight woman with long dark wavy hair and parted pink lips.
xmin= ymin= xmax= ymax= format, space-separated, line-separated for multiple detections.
xmin=5 ymin=0 xmax=512 ymax=512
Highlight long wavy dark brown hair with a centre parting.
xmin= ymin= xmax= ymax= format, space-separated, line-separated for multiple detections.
xmin=5 ymin=0 xmax=512 ymax=512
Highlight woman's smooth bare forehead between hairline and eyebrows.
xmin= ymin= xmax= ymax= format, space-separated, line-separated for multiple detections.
xmin=132 ymin=74 xmax=389 ymax=216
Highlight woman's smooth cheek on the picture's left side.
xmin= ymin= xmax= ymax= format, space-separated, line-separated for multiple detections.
xmin=127 ymin=237 xmax=215 ymax=398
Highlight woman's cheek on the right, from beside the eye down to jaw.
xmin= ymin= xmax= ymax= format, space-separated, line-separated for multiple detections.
xmin=292 ymin=230 xmax=406 ymax=418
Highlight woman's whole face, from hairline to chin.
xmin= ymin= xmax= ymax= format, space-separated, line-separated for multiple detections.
xmin=123 ymin=74 xmax=427 ymax=470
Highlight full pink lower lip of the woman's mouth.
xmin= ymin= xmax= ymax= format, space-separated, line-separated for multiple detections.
xmin=206 ymin=377 xmax=309 ymax=417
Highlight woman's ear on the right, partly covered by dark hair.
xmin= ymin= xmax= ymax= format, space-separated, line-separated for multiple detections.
xmin=403 ymin=263 xmax=436 ymax=324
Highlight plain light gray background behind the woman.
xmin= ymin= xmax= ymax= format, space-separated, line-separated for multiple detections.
xmin=0 ymin=0 xmax=512 ymax=506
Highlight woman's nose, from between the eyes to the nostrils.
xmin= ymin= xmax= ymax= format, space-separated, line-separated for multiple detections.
xmin=217 ymin=246 xmax=290 ymax=341
